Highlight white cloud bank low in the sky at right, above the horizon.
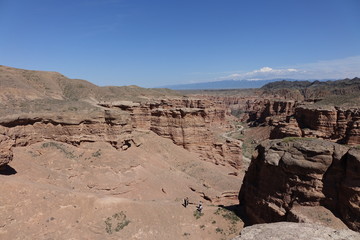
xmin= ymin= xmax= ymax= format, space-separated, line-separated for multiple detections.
xmin=219 ymin=56 xmax=360 ymax=81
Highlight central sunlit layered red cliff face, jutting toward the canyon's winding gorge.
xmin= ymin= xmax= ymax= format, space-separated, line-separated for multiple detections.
xmin=101 ymin=98 xmax=242 ymax=168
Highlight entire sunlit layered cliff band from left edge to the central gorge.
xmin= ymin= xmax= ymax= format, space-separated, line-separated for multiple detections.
xmin=0 ymin=99 xmax=242 ymax=168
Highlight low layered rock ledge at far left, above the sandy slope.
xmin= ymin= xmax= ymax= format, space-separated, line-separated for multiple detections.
xmin=0 ymin=110 xmax=140 ymax=166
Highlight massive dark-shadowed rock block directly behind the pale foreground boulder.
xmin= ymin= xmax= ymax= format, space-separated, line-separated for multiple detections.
xmin=239 ymin=139 xmax=360 ymax=231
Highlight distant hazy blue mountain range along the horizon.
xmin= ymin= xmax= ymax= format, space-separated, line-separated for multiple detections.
xmin=161 ymin=78 xmax=325 ymax=90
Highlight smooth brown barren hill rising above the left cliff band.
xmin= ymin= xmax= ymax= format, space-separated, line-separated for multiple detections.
xmin=0 ymin=65 xmax=180 ymax=114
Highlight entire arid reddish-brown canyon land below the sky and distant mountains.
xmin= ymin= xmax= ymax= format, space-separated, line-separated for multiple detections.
xmin=0 ymin=66 xmax=360 ymax=239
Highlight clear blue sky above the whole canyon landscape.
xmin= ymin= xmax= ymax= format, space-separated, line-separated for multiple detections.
xmin=0 ymin=0 xmax=360 ymax=87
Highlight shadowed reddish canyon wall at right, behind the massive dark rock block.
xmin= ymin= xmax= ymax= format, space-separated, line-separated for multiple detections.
xmin=242 ymin=99 xmax=360 ymax=145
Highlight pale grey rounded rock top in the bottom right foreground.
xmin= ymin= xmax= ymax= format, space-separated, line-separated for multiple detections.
xmin=232 ymin=222 xmax=360 ymax=240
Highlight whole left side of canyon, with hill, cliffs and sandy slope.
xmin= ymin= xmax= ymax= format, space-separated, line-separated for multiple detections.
xmin=0 ymin=67 xmax=243 ymax=239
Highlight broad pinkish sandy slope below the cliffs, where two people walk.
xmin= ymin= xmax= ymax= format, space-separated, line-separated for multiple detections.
xmin=0 ymin=131 xmax=243 ymax=239
